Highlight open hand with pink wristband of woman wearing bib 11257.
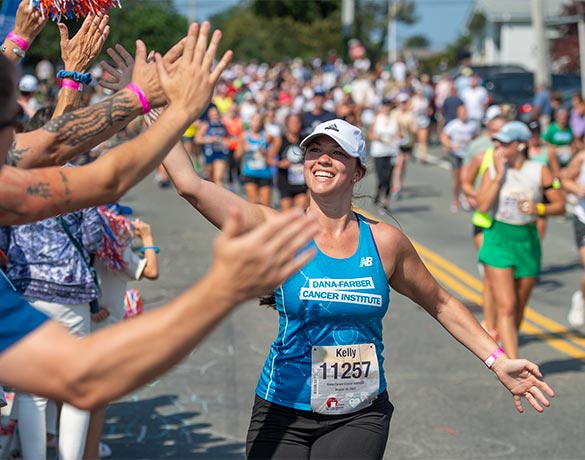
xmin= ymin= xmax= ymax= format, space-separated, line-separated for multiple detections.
xmin=493 ymin=358 xmax=555 ymax=413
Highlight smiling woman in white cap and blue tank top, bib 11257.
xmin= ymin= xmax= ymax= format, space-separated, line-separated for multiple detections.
xmin=164 ymin=119 xmax=553 ymax=459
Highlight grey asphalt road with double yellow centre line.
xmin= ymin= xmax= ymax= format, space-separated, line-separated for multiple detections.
xmin=104 ymin=148 xmax=585 ymax=459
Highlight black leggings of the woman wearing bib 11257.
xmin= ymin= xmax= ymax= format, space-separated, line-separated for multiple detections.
xmin=246 ymin=391 xmax=394 ymax=459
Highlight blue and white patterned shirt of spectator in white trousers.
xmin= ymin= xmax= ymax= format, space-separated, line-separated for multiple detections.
xmin=0 ymin=208 xmax=103 ymax=304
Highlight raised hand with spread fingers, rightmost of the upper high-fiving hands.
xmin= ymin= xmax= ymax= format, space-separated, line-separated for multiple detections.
xmin=156 ymin=22 xmax=232 ymax=119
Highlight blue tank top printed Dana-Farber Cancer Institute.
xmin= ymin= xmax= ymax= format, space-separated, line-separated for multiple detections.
xmin=256 ymin=214 xmax=390 ymax=411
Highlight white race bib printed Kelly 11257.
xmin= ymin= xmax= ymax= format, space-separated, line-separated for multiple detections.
xmin=311 ymin=343 xmax=380 ymax=414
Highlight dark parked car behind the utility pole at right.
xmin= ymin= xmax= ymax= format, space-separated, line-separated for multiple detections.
xmin=485 ymin=72 xmax=581 ymax=121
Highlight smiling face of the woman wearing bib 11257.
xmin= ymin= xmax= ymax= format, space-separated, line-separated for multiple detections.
xmin=305 ymin=135 xmax=363 ymax=192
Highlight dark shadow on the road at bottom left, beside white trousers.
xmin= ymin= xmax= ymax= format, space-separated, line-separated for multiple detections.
xmin=102 ymin=395 xmax=245 ymax=459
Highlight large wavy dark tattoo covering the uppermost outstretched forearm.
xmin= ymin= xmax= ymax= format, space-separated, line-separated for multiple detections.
xmin=42 ymin=92 xmax=136 ymax=147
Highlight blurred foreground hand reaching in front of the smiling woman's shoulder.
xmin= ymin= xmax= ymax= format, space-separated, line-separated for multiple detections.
xmin=210 ymin=210 xmax=319 ymax=302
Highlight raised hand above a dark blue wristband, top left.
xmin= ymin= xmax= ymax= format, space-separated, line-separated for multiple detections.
xmin=58 ymin=13 xmax=110 ymax=72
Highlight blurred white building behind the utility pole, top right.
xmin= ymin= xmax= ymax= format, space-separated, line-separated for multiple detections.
xmin=466 ymin=0 xmax=570 ymax=70
